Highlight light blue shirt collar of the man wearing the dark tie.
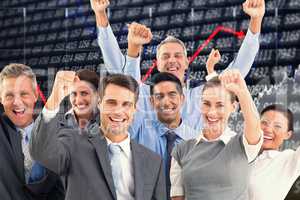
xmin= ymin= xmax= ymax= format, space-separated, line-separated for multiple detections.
xmin=154 ymin=119 xmax=195 ymax=140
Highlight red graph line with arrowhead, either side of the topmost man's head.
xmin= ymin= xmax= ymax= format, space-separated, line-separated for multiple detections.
xmin=142 ymin=26 xmax=245 ymax=82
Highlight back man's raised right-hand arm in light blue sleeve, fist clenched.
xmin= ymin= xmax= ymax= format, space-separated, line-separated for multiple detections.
xmin=228 ymin=0 xmax=265 ymax=78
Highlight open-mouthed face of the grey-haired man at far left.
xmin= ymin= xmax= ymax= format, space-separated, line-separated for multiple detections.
xmin=1 ymin=75 xmax=37 ymax=128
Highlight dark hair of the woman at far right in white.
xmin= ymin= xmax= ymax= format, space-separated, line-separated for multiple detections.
xmin=260 ymin=104 xmax=294 ymax=131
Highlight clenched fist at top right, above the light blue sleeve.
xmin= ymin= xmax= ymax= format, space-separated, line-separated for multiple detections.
xmin=243 ymin=0 xmax=265 ymax=18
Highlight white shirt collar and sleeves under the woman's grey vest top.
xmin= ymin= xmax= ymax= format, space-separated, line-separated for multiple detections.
xmin=170 ymin=127 xmax=266 ymax=200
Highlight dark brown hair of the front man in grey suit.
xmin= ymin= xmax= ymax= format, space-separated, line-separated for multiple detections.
xmin=98 ymin=74 xmax=139 ymax=103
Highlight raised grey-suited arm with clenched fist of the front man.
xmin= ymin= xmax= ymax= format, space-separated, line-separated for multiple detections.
xmin=29 ymin=71 xmax=75 ymax=175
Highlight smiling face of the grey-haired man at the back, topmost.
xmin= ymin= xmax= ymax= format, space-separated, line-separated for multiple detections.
xmin=157 ymin=42 xmax=189 ymax=83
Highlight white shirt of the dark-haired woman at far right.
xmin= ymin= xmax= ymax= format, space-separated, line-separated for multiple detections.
xmin=249 ymin=147 xmax=300 ymax=200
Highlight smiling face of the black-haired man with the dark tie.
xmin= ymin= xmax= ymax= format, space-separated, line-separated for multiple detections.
xmin=150 ymin=81 xmax=184 ymax=126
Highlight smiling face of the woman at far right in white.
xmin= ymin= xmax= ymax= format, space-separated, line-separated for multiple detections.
xmin=261 ymin=110 xmax=292 ymax=150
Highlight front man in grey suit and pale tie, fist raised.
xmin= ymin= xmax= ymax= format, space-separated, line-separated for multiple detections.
xmin=30 ymin=72 xmax=166 ymax=200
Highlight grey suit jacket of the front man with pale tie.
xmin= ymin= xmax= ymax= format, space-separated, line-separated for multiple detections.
xmin=30 ymin=111 xmax=166 ymax=200
